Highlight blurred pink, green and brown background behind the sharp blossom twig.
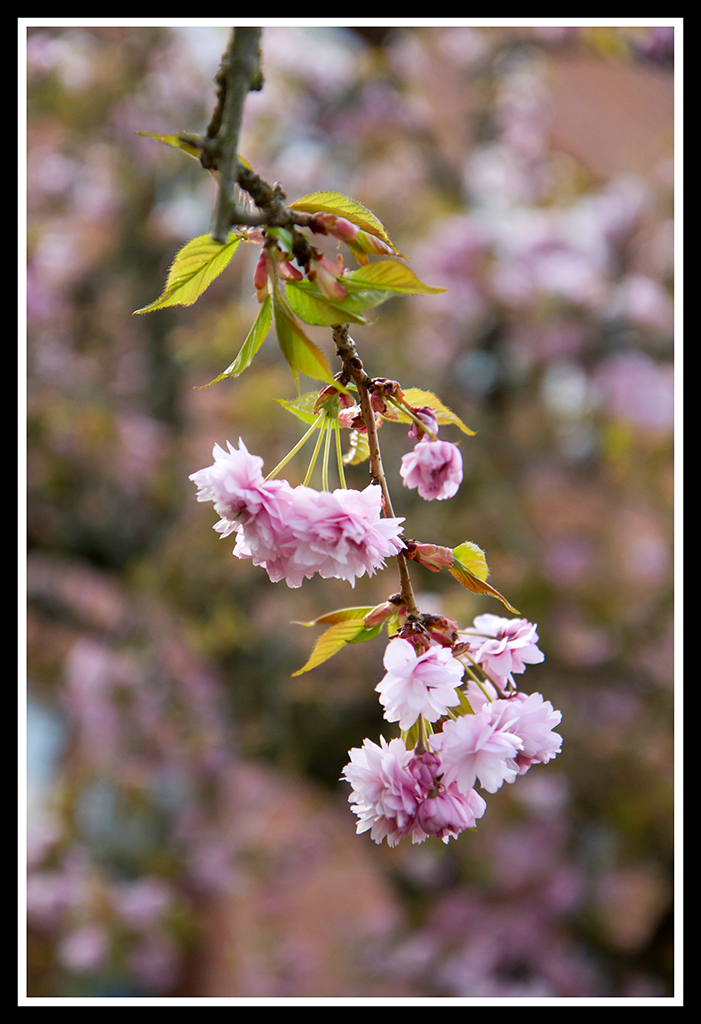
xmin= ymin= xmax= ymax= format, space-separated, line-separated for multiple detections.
xmin=27 ymin=27 xmax=673 ymax=997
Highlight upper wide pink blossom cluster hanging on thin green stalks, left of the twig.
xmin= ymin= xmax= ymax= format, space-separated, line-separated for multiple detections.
xmin=190 ymin=439 xmax=404 ymax=588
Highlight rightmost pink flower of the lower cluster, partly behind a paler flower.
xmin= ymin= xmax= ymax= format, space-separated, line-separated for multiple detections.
xmin=489 ymin=693 xmax=562 ymax=770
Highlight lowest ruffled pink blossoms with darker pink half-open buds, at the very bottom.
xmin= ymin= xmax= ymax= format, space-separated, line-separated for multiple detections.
xmin=343 ymin=736 xmax=486 ymax=846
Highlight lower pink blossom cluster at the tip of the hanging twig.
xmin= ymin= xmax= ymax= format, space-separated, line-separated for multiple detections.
xmin=343 ymin=615 xmax=562 ymax=846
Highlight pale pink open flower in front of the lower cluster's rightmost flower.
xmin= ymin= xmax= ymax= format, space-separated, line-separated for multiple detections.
xmin=431 ymin=709 xmax=523 ymax=793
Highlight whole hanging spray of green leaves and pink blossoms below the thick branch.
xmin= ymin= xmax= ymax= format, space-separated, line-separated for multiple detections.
xmin=159 ymin=123 xmax=562 ymax=846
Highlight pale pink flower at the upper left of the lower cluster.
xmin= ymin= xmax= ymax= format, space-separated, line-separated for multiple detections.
xmin=375 ymin=639 xmax=465 ymax=729
